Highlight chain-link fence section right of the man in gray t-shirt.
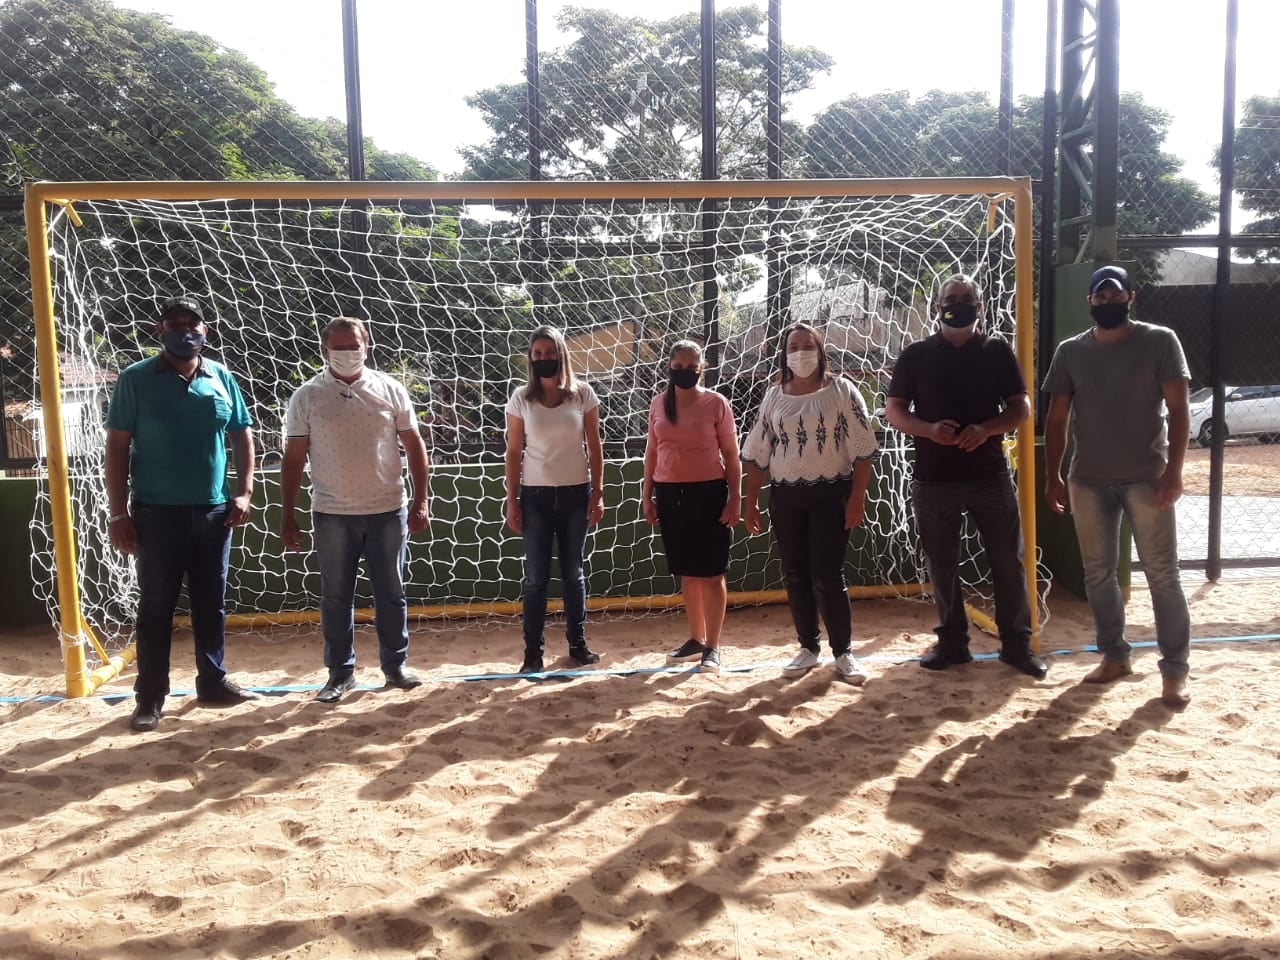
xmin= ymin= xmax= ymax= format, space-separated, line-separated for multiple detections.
xmin=1119 ymin=0 xmax=1280 ymax=575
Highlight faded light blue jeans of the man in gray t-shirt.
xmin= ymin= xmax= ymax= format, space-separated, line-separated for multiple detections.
xmin=1069 ymin=480 xmax=1192 ymax=677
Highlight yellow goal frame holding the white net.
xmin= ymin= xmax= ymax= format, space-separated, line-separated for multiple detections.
xmin=26 ymin=177 xmax=1039 ymax=696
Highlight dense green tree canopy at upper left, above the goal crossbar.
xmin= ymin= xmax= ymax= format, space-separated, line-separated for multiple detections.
xmin=0 ymin=0 xmax=435 ymax=180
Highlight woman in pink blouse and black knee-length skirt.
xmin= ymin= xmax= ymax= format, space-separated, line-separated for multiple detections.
xmin=644 ymin=340 xmax=742 ymax=672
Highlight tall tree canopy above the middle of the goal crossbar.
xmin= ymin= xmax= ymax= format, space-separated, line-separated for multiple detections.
xmin=462 ymin=6 xmax=833 ymax=179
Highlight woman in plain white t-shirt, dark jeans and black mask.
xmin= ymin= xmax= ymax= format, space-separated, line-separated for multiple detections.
xmin=507 ymin=326 xmax=604 ymax=673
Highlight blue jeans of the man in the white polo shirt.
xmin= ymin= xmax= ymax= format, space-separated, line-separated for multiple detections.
xmin=311 ymin=507 xmax=408 ymax=680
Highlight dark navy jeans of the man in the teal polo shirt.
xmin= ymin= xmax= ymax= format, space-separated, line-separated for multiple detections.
xmin=133 ymin=502 xmax=232 ymax=705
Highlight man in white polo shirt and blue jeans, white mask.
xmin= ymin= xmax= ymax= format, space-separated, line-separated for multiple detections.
xmin=280 ymin=317 xmax=428 ymax=703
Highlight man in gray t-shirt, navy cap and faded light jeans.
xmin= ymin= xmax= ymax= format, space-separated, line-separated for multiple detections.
xmin=1044 ymin=266 xmax=1190 ymax=708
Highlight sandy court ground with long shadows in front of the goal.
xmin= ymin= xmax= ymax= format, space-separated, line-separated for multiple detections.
xmin=0 ymin=575 xmax=1280 ymax=960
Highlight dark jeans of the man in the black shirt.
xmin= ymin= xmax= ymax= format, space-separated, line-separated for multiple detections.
xmin=911 ymin=474 xmax=1032 ymax=653
